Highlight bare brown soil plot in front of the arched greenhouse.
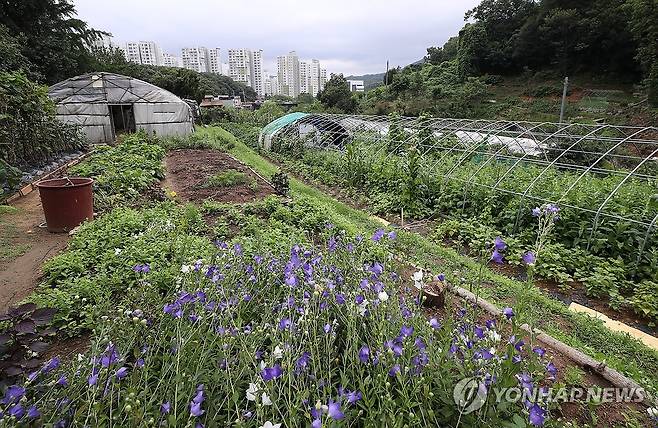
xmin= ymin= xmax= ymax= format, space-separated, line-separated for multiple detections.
xmin=167 ymin=149 xmax=276 ymax=204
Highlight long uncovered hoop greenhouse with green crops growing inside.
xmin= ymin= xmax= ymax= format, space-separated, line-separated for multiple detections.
xmin=260 ymin=114 xmax=658 ymax=269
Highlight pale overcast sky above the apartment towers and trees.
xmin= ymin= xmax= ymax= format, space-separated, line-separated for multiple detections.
xmin=74 ymin=0 xmax=479 ymax=75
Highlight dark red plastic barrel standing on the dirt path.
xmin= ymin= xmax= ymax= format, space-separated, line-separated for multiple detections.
xmin=37 ymin=177 xmax=94 ymax=233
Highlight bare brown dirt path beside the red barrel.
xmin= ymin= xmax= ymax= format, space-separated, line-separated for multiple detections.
xmin=0 ymin=190 xmax=69 ymax=313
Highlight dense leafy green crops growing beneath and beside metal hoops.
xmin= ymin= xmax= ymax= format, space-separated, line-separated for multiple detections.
xmin=266 ymin=139 xmax=658 ymax=319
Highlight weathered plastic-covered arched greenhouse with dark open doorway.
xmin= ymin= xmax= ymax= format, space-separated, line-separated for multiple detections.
xmin=48 ymin=73 xmax=194 ymax=143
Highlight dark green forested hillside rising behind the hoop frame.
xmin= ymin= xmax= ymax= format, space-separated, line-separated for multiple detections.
xmin=336 ymin=0 xmax=658 ymax=124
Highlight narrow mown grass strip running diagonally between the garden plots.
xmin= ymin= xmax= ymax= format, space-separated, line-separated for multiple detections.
xmin=204 ymin=124 xmax=658 ymax=393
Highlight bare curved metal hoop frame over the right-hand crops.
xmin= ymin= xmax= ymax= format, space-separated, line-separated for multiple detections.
xmin=260 ymin=113 xmax=658 ymax=259
